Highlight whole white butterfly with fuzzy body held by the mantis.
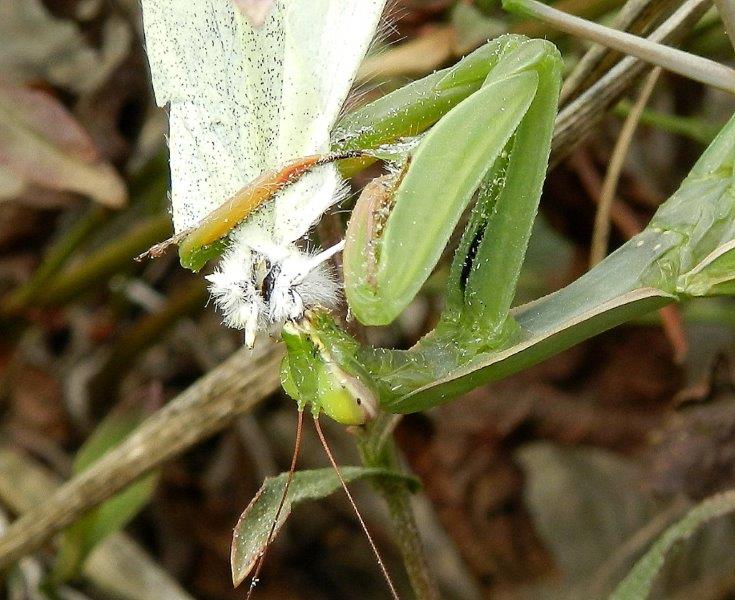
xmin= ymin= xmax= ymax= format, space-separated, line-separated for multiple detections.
xmin=142 ymin=0 xmax=386 ymax=346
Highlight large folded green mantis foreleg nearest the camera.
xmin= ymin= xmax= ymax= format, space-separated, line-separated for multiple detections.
xmin=344 ymin=38 xmax=561 ymax=344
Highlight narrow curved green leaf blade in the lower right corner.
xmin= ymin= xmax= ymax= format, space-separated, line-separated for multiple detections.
xmin=610 ymin=490 xmax=735 ymax=600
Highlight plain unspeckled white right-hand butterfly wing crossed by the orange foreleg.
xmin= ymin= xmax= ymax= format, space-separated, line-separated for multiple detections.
xmin=275 ymin=0 xmax=386 ymax=241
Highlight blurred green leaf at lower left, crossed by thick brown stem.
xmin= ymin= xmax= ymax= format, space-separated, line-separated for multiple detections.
xmin=49 ymin=413 xmax=157 ymax=585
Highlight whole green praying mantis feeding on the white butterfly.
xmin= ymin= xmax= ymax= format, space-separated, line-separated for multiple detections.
xmin=174 ymin=30 xmax=735 ymax=425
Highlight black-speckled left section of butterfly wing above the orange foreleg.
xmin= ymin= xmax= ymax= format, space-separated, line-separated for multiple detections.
xmin=142 ymin=0 xmax=284 ymax=231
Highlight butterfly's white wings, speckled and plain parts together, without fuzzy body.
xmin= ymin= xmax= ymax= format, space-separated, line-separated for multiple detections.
xmin=142 ymin=0 xmax=384 ymax=240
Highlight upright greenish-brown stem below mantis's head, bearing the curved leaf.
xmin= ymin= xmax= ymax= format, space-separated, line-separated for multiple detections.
xmin=358 ymin=413 xmax=441 ymax=600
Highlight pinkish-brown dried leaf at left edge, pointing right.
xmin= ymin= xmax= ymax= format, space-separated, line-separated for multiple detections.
xmin=0 ymin=86 xmax=127 ymax=208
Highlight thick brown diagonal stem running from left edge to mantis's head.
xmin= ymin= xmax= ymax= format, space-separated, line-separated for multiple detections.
xmin=0 ymin=344 xmax=283 ymax=570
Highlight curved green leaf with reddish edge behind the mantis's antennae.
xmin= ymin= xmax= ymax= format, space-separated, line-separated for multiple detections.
xmin=230 ymin=467 xmax=419 ymax=586
